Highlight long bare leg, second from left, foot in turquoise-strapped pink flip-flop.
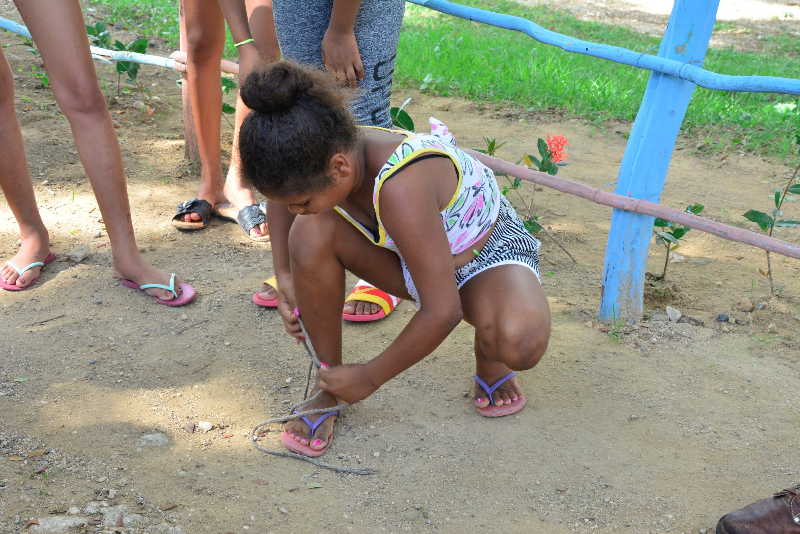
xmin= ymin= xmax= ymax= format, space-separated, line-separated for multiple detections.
xmin=15 ymin=0 xmax=184 ymax=299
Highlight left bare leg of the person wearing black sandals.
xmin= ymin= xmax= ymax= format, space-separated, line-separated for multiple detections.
xmin=184 ymin=0 xmax=226 ymax=222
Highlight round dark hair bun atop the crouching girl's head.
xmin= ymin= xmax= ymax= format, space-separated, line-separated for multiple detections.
xmin=240 ymin=61 xmax=314 ymax=113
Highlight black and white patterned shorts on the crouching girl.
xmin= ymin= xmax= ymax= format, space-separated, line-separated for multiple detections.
xmin=400 ymin=196 xmax=541 ymax=307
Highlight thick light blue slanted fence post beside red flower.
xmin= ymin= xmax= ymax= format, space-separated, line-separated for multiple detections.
xmin=599 ymin=0 xmax=719 ymax=321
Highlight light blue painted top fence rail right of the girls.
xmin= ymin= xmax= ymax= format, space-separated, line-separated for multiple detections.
xmin=407 ymin=0 xmax=800 ymax=95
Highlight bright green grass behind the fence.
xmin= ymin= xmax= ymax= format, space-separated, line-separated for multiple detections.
xmin=91 ymin=0 xmax=800 ymax=158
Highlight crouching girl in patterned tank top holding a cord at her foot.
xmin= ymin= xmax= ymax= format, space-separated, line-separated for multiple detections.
xmin=239 ymin=62 xmax=550 ymax=456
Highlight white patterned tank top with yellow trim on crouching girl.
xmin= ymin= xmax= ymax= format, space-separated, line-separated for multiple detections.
xmin=334 ymin=117 xmax=500 ymax=255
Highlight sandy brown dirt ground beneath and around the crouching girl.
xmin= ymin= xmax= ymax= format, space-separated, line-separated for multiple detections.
xmin=0 ymin=4 xmax=800 ymax=534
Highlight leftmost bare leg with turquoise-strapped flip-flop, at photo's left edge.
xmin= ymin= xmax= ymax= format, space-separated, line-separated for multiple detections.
xmin=0 ymin=49 xmax=50 ymax=287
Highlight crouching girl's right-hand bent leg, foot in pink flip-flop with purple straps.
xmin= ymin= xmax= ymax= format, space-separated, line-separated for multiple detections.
xmin=461 ymin=265 xmax=550 ymax=416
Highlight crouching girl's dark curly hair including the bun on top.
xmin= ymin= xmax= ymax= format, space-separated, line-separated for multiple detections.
xmin=239 ymin=61 xmax=358 ymax=196
